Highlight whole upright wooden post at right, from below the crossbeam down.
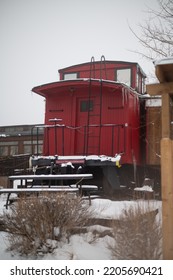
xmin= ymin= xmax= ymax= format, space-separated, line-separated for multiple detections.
xmin=161 ymin=94 xmax=173 ymax=260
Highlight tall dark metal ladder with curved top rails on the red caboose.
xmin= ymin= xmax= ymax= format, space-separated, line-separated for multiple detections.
xmin=86 ymin=56 xmax=107 ymax=155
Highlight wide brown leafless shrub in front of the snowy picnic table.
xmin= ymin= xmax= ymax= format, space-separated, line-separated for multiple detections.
xmin=4 ymin=193 xmax=90 ymax=254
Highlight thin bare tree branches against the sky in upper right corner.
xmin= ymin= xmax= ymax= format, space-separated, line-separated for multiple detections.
xmin=129 ymin=0 xmax=173 ymax=60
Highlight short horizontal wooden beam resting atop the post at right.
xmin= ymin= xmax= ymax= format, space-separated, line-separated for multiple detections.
xmin=146 ymin=82 xmax=173 ymax=96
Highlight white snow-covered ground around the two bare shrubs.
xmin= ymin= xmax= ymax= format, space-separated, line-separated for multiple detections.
xmin=0 ymin=194 xmax=161 ymax=260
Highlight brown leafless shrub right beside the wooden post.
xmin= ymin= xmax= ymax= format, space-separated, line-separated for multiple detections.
xmin=109 ymin=204 xmax=162 ymax=260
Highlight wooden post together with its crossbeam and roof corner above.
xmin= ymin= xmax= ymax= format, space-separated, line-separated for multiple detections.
xmin=147 ymin=64 xmax=173 ymax=260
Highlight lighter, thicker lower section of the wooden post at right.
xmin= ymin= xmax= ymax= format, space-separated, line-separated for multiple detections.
xmin=161 ymin=138 xmax=173 ymax=260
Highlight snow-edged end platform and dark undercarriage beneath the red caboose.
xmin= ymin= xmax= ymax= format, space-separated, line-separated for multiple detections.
xmin=30 ymin=155 xmax=160 ymax=195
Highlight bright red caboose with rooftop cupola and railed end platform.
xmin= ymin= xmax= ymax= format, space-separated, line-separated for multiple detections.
xmin=33 ymin=57 xmax=146 ymax=191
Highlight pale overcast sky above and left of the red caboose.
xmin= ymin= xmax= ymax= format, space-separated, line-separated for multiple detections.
xmin=0 ymin=0 xmax=158 ymax=126
